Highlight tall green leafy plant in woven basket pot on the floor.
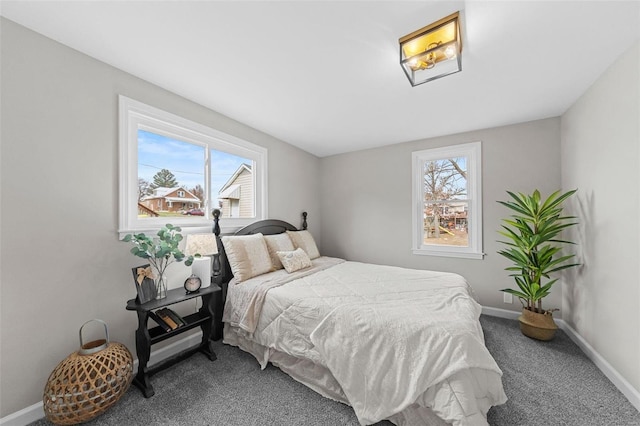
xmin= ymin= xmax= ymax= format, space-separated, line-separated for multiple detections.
xmin=498 ymin=189 xmax=579 ymax=340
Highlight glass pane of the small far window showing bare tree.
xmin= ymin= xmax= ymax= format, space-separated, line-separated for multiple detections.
xmin=423 ymin=157 xmax=469 ymax=247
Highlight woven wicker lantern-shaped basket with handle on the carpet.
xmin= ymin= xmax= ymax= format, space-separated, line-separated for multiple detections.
xmin=43 ymin=320 xmax=133 ymax=425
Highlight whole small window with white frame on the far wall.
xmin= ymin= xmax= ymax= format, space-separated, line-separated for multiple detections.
xmin=412 ymin=142 xmax=483 ymax=259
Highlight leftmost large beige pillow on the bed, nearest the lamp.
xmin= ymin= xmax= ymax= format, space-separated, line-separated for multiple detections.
xmin=222 ymin=234 xmax=273 ymax=282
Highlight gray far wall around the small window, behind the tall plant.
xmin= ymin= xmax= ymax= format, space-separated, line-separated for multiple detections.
xmin=321 ymin=118 xmax=561 ymax=311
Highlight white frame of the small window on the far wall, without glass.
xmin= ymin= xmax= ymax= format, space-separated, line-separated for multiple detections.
xmin=411 ymin=142 xmax=484 ymax=259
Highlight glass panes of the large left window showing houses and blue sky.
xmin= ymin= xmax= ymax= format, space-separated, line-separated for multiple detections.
xmin=138 ymin=129 xmax=255 ymax=218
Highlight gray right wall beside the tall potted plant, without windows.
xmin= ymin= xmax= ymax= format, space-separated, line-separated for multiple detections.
xmin=561 ymin=43 xmax=640 ymax=392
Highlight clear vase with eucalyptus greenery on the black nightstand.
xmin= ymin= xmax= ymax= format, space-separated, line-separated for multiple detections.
xmin=122 ymin=224 xmax=198 ymax=299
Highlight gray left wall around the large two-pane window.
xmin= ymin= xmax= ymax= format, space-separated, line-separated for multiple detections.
xmin=0 ymin=18 xmax=322 ymax=417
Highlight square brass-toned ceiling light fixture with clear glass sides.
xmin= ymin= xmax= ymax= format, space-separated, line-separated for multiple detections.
xmin=399 ymin=12 xmax=462 ymax=86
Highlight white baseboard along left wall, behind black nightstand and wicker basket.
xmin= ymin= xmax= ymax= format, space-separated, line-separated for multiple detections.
xmin=0 ymin=332 xmax=202 ymax=426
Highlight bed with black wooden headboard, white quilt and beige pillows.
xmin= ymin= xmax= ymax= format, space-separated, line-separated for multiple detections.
xmin=214 ymin=213 xmax=507 ymax=426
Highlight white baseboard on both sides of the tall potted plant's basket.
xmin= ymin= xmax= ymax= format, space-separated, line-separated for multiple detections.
xmin=482 ymin=306 xmax=640 ymax=411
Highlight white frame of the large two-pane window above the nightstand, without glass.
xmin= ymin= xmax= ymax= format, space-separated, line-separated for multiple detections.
xmin=118 ymin=95 xmax=268 ymax=238
